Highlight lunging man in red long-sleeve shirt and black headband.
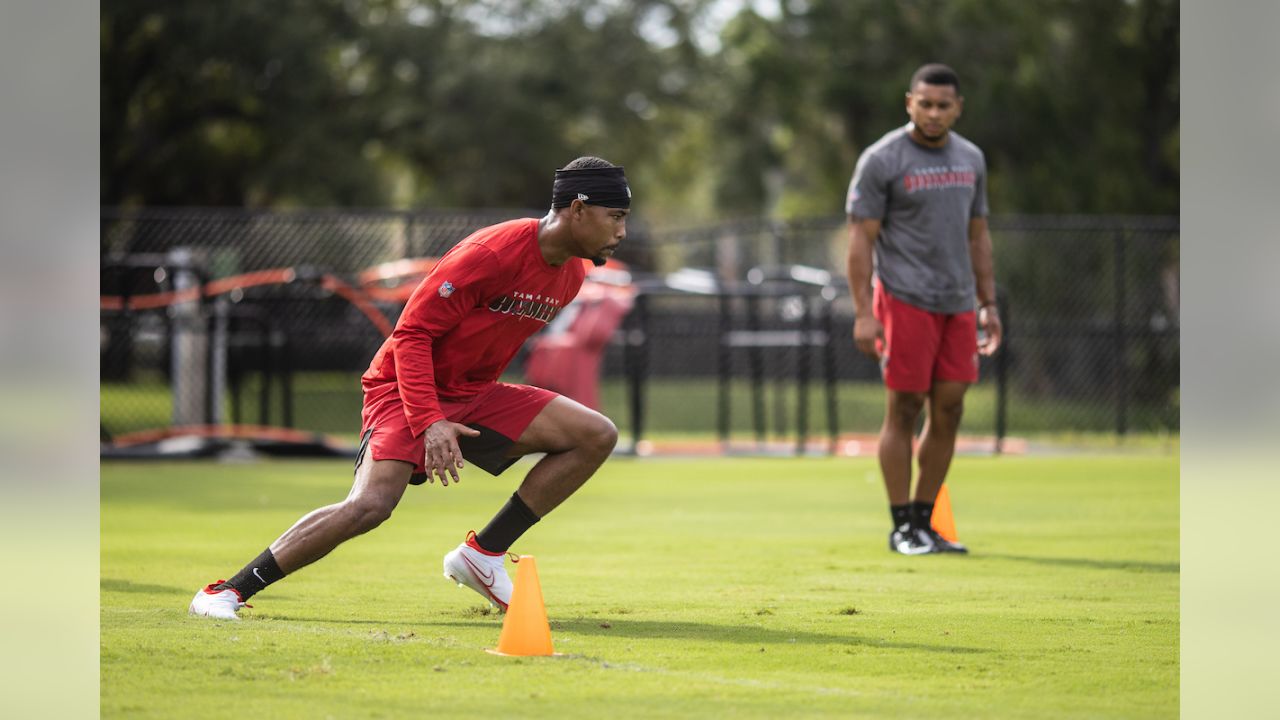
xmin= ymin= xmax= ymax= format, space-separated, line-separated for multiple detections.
xmin=189 ymin=158 xmax=631 ymax=620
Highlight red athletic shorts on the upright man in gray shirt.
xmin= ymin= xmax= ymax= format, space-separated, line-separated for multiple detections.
xmin=872 ymin=283 xmax=978 ymax=392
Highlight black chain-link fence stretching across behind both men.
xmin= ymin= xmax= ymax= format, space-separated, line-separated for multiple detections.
xmin=101 ymin=209 xmax=1179 ymax=453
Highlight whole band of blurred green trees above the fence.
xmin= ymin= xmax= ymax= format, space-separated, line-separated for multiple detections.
xmin=101 ymin=0 xmax=1179 ymax=215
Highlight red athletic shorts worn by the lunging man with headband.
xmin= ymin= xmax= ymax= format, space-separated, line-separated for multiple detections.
xmin=356 ymin=383 xmax=557 ymax=486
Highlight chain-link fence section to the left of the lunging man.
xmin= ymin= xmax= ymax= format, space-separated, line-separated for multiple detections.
xmin=101 ymin=209 xmax=539 ymax=438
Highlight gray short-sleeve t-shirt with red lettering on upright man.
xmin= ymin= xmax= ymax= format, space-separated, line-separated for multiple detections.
xmin=845 ymin=124 xmax=987 ymax=313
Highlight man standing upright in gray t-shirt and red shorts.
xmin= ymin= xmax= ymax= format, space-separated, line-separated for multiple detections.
xmin=845 ymin=64 xmax=1001 ymax=555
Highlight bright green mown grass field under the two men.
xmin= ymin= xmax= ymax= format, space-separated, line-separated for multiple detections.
xmin=101 ymin=455 xmax=1179 ymax=719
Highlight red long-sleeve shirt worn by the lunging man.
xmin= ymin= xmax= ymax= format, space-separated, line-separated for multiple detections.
xmin=360 ymin=219 xmax=586 ymax=437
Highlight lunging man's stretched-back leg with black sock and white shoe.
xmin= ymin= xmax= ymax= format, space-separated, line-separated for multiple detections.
xmin=191 ymin=447 xmax=413 ymax=620
